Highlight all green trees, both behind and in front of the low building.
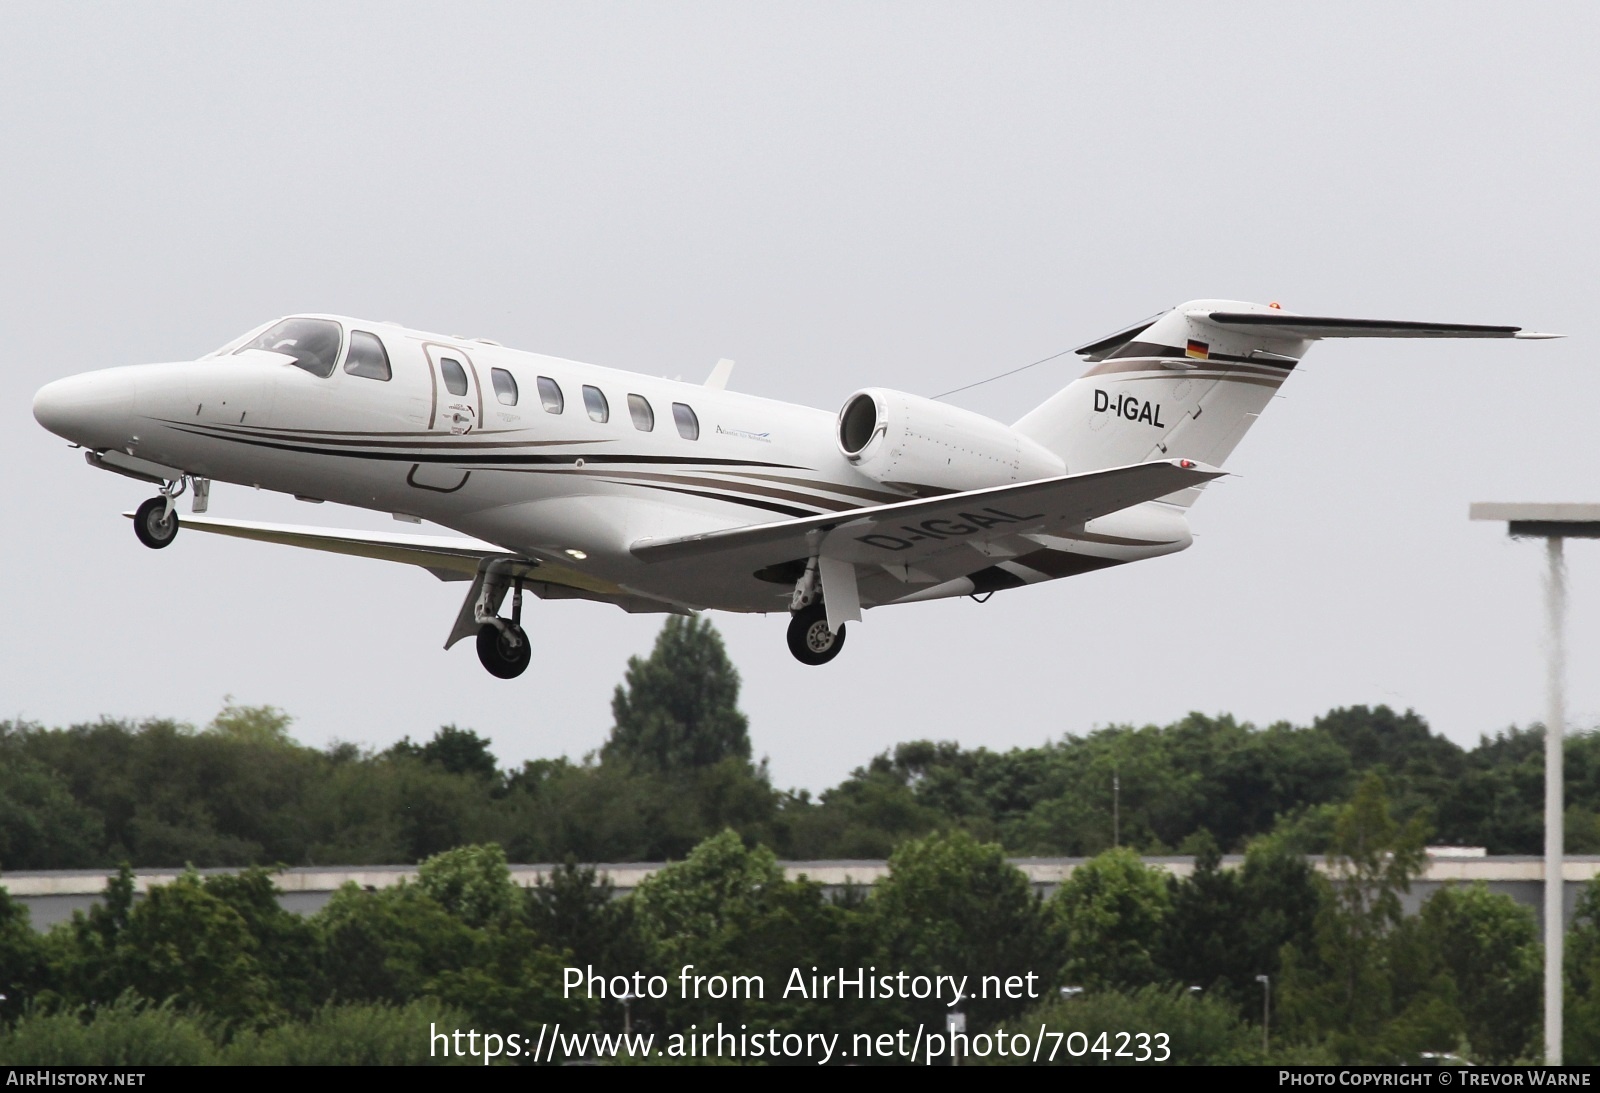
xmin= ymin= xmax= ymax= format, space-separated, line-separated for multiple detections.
xmin=0 ymin=618 xmax=1600 ymax=1064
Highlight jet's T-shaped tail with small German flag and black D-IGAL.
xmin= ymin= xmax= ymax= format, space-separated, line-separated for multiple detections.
xmin=1013 ymin=299 xmax=1547 ymax=506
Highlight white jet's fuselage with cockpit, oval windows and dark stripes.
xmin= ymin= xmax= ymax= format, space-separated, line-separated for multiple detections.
xmin=34 ymin=315 xmax=1190 ymax=611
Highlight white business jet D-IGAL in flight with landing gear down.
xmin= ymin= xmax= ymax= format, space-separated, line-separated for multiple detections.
xmin=34 ymin=301 xmax=1550 ymax=679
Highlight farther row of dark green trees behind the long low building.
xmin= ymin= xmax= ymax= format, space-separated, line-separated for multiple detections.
xmin=0 ymin=618 xmax=1600 ymax=869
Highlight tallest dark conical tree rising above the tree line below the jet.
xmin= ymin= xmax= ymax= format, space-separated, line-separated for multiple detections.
xmin=603 ymin=615 xmax=750 ymax=771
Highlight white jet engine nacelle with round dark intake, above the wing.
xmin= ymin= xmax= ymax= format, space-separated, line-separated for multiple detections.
xmin=838 ymin=387 xmax=1067 ymax=491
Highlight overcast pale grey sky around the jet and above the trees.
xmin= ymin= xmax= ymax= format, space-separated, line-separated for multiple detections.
xmin=0 ymin=0 xmax=1600 ymax=789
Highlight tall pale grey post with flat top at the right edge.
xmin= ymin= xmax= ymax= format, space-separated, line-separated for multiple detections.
xmin=1469 ymin=502 xmax=1600 ymax=1066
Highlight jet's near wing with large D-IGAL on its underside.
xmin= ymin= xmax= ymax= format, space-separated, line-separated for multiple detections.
xmin=632 ymin=459 xmax=1224 ymax=579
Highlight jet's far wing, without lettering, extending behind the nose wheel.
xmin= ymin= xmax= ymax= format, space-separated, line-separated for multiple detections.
xmin=140 ymin=512 xmax=683 ymax=613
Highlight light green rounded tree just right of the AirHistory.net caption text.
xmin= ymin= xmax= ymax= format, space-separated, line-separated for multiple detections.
xmin=1050 ymin=848 xmax=1171 ymax=991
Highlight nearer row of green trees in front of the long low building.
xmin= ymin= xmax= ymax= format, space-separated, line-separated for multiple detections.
xmin=9 ymin=793 xmax=1600 ymax=1064
